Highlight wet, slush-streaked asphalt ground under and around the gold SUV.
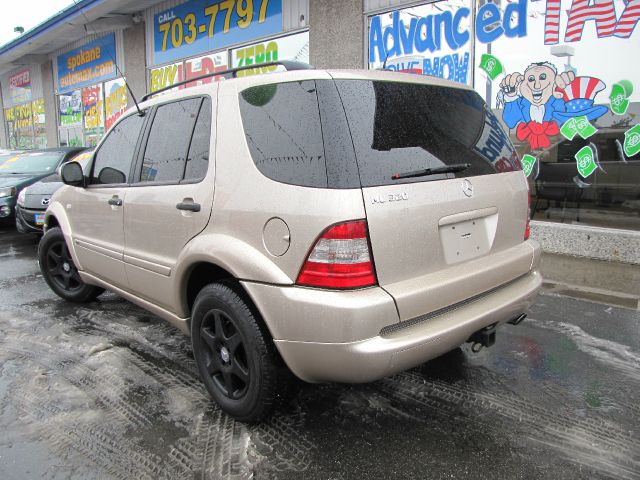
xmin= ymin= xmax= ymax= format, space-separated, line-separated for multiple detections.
xmin=0 ymin=226 xmax=640 ymax=480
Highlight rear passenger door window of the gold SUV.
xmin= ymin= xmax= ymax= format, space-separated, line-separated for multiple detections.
xmin=140 ymin=98 xmax=202 ymax=182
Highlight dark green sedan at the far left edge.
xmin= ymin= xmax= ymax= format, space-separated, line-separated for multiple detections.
xmin=0 ymin=147 xmax=84 ymax=220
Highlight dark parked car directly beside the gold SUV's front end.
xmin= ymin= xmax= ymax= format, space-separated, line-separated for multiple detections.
xmin=16 ymin=150 xmax=93 ymax=233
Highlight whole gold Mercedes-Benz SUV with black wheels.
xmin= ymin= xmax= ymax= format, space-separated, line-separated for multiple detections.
xmin=39 ymin=65 xmax=541 ymax=421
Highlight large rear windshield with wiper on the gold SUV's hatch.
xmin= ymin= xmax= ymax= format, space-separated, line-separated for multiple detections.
xmin=335 ymin=80 xmax=519 ymax=187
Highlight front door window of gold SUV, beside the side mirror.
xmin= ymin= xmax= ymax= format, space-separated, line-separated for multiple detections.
xmin=91 ymin=115 xmax=144 ymax=184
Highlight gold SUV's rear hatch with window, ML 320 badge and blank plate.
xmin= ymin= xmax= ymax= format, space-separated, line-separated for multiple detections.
xmin=335 ymin=78 xmax=533 ymax=320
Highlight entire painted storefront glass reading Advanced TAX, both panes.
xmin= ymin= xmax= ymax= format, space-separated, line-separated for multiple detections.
xmin=367 ymin=0 xmax=640 ymax=230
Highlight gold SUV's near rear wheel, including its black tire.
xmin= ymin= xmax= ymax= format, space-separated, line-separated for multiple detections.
xmin=191 ymin=283 xmax=292 ymax=423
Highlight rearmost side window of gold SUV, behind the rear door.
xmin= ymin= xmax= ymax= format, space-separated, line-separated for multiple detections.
xmin=240 ymin=81 xmax=327 ymax=187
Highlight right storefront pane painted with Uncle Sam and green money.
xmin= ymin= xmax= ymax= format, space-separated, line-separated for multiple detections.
xmin=475 ymin=0 xmax=640 ymax=230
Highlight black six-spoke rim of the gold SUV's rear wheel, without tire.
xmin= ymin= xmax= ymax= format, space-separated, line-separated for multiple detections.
xmin=200 ymin=309 xmax=251 ymax=400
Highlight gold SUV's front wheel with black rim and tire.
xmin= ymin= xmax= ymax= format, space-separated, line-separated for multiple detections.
xmin=38 ymin=227 xmax=104 ymax=303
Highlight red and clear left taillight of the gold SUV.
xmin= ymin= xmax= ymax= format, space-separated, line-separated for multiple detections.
xmin=297 ymin=220 xmax=376 ymax=289
